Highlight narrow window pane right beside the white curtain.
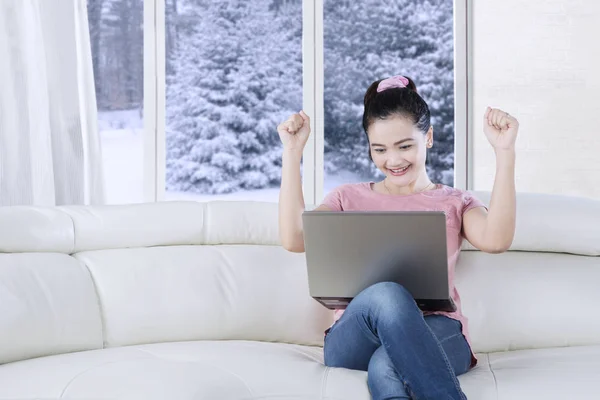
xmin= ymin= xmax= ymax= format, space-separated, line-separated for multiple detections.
xmin=88 ymin=0 xmax=144 ymax=204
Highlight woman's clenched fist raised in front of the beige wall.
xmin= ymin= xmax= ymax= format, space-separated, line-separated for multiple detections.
xmin=483 ymin=107 xmax=519 ymax=150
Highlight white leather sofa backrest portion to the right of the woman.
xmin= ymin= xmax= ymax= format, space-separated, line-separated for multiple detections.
xmin=456 ymin=192 xmax=600 ymax=352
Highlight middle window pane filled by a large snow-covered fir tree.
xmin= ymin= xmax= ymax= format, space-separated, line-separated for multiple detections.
xmin=165 ymin=0 xmax=302 ymax=201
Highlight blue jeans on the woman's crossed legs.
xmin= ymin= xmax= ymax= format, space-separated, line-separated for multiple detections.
xmin=324 ymin=282 xmax=471 ymax=400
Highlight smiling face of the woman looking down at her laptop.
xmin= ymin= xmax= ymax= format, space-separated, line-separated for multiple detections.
xmin=369 ymin=117 xmax=433 ymax=186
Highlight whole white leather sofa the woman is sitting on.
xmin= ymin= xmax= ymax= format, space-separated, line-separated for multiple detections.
xmin=0 ymin=193 xmax=600 ymax=400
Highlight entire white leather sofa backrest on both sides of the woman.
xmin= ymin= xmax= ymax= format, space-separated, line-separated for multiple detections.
xmin=0 ymin=192 xmax=600 ymax=363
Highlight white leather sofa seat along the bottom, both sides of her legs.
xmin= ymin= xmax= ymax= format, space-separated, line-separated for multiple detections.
xmin=0 ymin=341 xmax=600 ymax=400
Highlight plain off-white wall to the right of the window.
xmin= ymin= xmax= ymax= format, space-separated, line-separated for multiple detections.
xmin=470 ymin=0 xmax=600 ymax=199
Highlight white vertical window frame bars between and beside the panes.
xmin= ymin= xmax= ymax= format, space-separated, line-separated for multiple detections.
xmin=143 ymin=0 xmax=473 ymax=205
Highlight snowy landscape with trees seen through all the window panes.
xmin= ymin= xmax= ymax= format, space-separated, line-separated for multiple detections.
xmin=88 ymin=0 xmax=454 ymax=203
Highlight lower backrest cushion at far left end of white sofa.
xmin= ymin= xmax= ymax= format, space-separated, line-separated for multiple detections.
xmin=0 ymin=253 xmax=102 ymax=368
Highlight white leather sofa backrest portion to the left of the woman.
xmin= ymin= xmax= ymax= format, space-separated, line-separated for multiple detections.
xmin=0 ymin=202 xmax=332 ymax=363
